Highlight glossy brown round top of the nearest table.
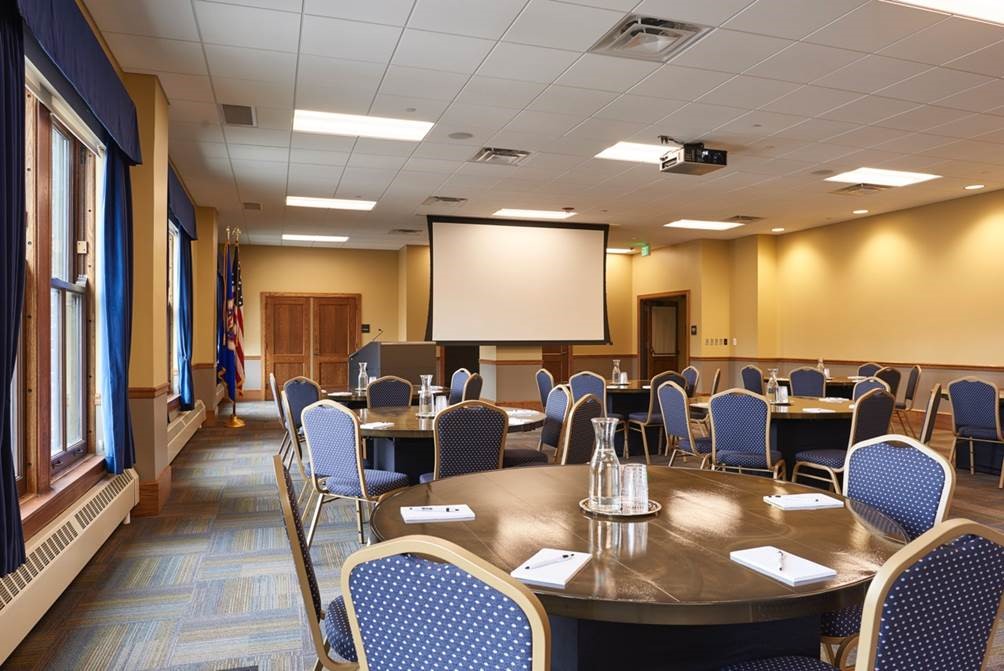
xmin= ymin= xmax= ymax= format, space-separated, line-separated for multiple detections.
xmin=370 ymin=465 xmax=906 ymax=625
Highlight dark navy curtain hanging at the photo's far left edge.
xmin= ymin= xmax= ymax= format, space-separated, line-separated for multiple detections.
xmin=0 ymin=4 xmax=25 ymax=576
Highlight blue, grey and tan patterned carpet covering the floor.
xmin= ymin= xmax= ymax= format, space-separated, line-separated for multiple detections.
xmin=9 ymin=403 xmax=1004 ymax=671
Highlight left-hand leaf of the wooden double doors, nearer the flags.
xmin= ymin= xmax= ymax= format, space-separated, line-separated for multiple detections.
xmin=262 ymin=295 xmax=310 ymax=400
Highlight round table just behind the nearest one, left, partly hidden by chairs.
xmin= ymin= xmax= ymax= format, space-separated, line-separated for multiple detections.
xmin=356 ymin=406 xmax=544 ymax=484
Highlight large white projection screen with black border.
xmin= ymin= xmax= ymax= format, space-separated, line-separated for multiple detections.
xmin=426 ymin=216 xmax=609 ymax=345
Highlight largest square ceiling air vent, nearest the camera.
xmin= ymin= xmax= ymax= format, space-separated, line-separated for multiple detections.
xmin=589 ymin=14 xmax=711 ymax=63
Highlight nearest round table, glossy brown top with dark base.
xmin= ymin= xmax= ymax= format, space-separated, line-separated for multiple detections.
xmin=370 ymin=465 xmax=907 ymax=671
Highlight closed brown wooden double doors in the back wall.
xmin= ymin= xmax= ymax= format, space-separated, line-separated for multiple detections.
xmin=262 ymin=293 xmax=361 ymax=399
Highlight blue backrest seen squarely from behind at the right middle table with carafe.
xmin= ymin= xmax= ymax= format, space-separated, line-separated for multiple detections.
xmin=708 ymin=389 xmax=773 ymax=466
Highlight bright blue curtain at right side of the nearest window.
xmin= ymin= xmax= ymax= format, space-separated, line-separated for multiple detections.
xmin=98 ymin=145 xmax=136 ymax=473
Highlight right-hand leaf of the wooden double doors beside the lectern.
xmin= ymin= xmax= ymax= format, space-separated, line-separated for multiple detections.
xmin=310 ymin=296 xmax=360 ymax=389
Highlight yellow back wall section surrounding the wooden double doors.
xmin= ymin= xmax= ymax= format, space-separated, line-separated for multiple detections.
xmin=241 ymin=245 xmax=400 ymax=357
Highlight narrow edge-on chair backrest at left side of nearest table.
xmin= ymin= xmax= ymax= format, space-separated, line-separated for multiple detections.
xmin=272 ymin=454 xmax=356 ymax=671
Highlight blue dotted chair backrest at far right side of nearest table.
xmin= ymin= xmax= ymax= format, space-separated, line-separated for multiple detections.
xmin=843 ymin=435 xmax=955 ymax=538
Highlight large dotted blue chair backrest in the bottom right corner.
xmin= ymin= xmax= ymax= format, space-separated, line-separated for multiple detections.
xmin=854 ymin=519 xmax=1004 ymax=671
